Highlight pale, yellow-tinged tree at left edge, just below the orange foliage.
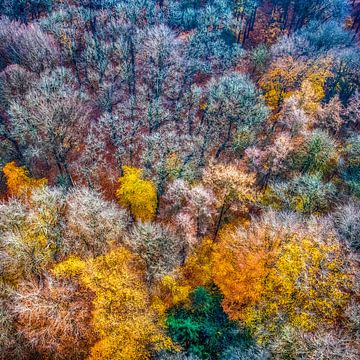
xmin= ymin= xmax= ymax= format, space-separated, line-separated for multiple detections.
xmin=0 ymin=187 xmax=64 ymax=287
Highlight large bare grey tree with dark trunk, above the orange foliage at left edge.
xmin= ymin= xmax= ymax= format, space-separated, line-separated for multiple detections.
xmin=9 ymin=68 xmax=89 ymax=183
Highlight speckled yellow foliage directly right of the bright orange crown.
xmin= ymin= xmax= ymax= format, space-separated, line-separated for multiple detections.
xmin=245 ymin=237 xmax=351 ymax=338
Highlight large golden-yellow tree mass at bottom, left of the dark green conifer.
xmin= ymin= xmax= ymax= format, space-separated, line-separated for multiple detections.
xmin=54 ymin=248 xmax=172 ymax=360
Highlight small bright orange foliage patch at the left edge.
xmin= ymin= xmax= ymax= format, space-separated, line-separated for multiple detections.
xmin=3 ymin=161 xmax=47 ymax=196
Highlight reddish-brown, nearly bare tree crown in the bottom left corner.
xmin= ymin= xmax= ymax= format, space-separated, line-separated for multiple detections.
xmin=12 ymin=276 xmax=94 ymax=359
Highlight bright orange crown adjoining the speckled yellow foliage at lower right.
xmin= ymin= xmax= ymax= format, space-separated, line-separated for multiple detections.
xmin=212 ymin=213 xmax=288 ymax=320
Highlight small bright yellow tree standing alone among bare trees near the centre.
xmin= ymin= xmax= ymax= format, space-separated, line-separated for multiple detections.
xmin=116 ymin=166 xmax=157 ymax=221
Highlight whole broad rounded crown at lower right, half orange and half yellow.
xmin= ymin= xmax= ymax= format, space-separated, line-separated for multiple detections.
xmin=213 ymin=214 xmax=352 ymax=341
